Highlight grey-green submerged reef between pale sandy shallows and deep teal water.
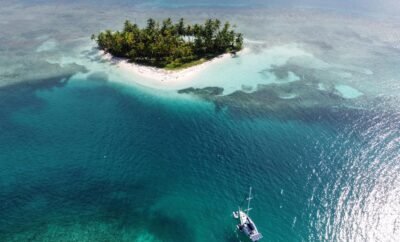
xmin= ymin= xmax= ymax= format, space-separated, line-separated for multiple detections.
xmin=178 ymin=79 xmax=372 ymax=124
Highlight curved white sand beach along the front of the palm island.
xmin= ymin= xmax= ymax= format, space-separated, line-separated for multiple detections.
xmin=100 ymin=51 xmax=236 ymax=89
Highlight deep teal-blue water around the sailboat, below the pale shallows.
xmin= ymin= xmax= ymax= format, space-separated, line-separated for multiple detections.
xmin=0 ymin=77 xmax=399 ymax=241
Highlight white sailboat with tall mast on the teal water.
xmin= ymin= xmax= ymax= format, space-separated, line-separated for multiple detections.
xmin=233 ymin=187 xmax=263 ymax=242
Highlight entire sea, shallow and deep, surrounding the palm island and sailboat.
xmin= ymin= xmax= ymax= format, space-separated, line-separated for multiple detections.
xmin=0 ymin=0 xmax=400 ymax=242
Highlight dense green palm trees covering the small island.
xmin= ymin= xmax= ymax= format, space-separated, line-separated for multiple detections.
xmin=92 ymin=18 xmax=243 ymax=69
